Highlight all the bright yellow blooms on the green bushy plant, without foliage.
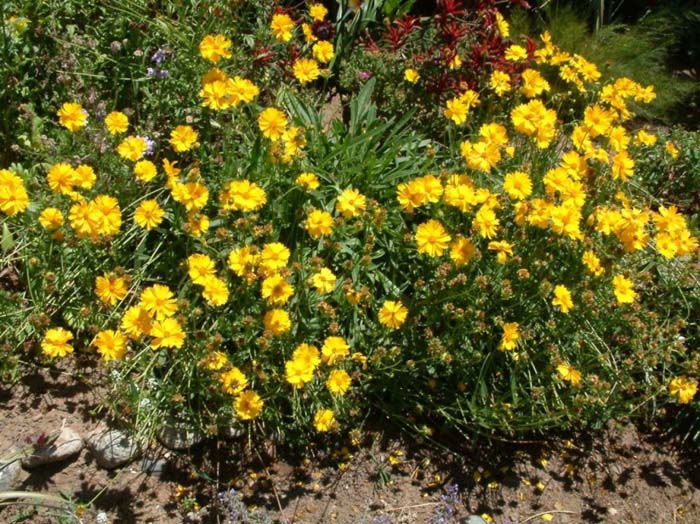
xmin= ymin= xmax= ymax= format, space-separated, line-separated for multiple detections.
xmin=5 ymin=14 xmax=698 ymax=432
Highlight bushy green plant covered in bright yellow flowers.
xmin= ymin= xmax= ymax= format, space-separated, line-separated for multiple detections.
xmin=0 ymin=2 xmax=698 ymax=448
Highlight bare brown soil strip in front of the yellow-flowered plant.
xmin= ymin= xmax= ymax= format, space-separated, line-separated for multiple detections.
xmin=0 ymin=362 xmax=700 ymax=524
